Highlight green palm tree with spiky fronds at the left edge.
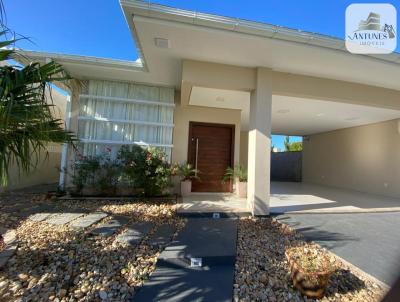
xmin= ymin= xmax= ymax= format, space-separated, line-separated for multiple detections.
xmin=0 ymin=28 xmax=74 ymax=185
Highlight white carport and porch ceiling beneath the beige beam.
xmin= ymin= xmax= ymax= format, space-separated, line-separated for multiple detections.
xmin=189 ymin=87 xmax=400 ymax=136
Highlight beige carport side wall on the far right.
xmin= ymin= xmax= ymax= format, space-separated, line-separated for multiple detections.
xmin=303 ymin=120 xmax=400 ymax=197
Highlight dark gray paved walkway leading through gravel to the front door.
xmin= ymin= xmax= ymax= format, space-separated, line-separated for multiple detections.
xmin=134 ymin=218 xmax=237 ymax=302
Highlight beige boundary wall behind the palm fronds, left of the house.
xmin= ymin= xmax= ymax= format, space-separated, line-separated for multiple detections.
xmin=0 ymin=89 xmax=67 ymax=191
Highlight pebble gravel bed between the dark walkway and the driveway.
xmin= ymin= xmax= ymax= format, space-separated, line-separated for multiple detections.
xmin=234 ymin=217 xmax=385 ymax=302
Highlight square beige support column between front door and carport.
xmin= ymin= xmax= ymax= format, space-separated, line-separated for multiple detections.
xmin=247 ymin=68 xmax=272 ymax=216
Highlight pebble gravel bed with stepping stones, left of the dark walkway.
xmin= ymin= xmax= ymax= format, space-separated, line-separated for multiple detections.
xmin=0 ymin=195 xmax=184 ymax=301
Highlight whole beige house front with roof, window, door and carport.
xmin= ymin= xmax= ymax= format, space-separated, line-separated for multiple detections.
xmin=18 ymin=0 xmax=400 ymax=215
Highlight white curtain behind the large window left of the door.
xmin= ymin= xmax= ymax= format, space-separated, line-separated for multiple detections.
xmin=78 ymin=80 xmax=174 ymax=159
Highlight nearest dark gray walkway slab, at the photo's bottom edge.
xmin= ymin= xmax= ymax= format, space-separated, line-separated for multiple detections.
xmin=133 ymin=262 xmax=234 ymax=302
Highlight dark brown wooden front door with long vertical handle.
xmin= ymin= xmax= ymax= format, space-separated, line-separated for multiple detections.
xmin=188 ymin=122 xmax=235 ymax=192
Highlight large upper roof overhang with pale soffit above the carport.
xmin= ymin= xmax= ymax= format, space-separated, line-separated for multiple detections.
xmin=120 ymin=0 xmax=400 ymax=90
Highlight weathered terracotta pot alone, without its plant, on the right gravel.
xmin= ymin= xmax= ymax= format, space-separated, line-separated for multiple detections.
xmin=285 ymin=252 xmax=333 ymax=299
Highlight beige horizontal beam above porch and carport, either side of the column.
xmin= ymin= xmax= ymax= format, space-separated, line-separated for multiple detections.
xmin=181 ymin=60 xmax=400 ymax=110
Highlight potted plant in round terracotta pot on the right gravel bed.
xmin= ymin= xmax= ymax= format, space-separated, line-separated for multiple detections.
xmin=285 ymin=245 xmax=336 ymax=299
